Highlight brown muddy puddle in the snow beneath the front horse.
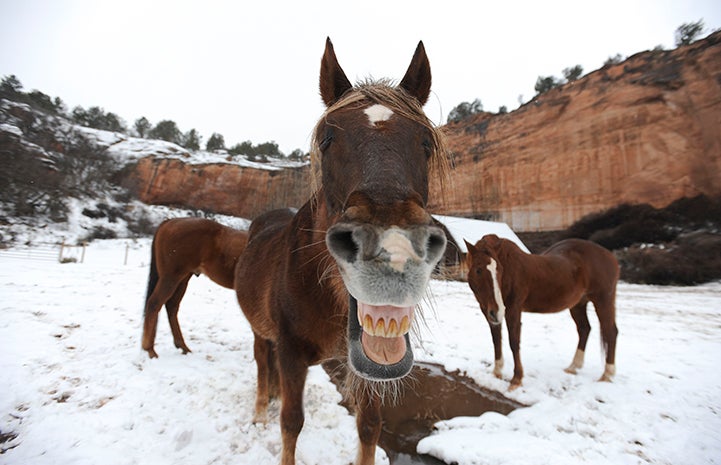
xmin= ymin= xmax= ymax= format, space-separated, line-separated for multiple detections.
xmin=324 ymin=362 xmax=523 ymax=465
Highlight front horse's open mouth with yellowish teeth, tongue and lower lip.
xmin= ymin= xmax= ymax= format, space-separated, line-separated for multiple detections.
xmin=348 ymin=297 xmax=413 ymax=381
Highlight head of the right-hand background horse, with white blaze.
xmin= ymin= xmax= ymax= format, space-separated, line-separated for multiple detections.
xmin=466 ymin=234 xmax=506 ymax=324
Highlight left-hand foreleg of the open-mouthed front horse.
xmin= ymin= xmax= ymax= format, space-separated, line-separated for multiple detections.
xmin=276 ymin=346 xmax=308 ymax=465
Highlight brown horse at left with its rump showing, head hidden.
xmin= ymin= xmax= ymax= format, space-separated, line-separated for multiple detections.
xmin=142 ymin=218 xmax=248 ymax=358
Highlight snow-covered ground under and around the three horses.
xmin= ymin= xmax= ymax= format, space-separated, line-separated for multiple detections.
xmin=0 ymin=240 xmax=721 ymax=465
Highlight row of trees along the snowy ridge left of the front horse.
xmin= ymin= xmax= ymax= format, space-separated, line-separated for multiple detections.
xmin=0 ymin=74 xmax=307 ymax=162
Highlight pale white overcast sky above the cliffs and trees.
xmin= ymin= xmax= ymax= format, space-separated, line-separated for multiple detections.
xmin=0 ymin=0 xmax=721 ymax=153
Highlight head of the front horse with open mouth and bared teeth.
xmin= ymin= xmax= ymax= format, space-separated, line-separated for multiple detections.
xmin=311 ymin=39 xmax=446 ymax=380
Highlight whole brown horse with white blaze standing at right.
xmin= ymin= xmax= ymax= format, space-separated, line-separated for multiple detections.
xmin=466 ymin=234 xmax=619 ymax=390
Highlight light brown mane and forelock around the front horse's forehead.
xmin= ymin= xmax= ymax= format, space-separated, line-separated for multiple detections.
xmin=310 ymin=79 xmax=450 ymax=198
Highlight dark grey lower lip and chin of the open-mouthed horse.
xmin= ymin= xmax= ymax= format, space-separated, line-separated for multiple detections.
xmin=348 ymin=295 xmax=413 ymax=381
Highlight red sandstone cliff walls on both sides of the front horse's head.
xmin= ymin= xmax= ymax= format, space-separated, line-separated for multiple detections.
xmin=126 ymin=32 xmax=721 ymax=232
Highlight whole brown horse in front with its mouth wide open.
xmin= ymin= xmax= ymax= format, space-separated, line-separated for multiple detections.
xmin=235 ymin=40 xmax=447 ymax=465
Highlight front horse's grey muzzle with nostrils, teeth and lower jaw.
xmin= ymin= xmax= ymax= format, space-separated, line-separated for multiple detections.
xmin=326 ymin=223 xmax=446 ymax=380
